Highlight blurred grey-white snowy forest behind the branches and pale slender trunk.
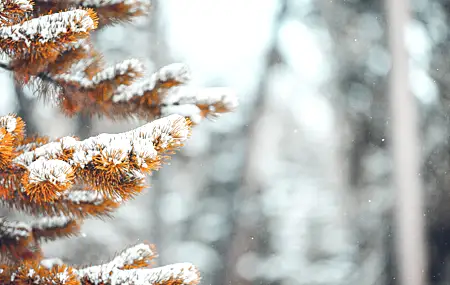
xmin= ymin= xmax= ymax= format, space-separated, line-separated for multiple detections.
xmin=0 ymin=0 xmax=450 ymax=285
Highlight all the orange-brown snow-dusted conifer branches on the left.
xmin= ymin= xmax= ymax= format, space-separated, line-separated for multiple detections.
xmin=0 ymin=0 xmax=237 ymax=285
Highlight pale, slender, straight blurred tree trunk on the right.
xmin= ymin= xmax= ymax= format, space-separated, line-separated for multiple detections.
xmin=386 ymin=0 xmax=427 ymax=285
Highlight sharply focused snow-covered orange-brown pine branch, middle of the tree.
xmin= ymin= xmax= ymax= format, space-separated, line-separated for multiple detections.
xmin=0 ymin=112 xmax=190 ymax=208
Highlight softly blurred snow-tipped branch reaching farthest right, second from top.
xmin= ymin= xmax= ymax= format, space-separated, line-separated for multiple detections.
xmin=0 ymin=55 xmax=237 ymax=124
